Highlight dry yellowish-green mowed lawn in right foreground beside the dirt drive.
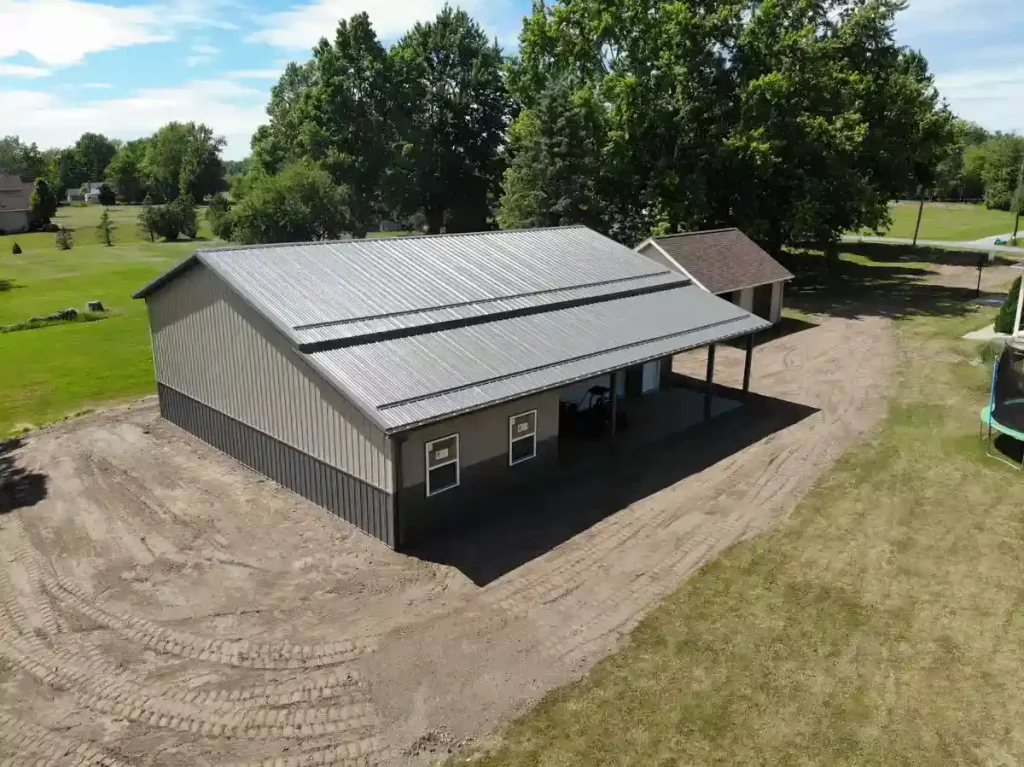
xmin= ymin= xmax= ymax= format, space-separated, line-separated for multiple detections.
xmin=453 ymin=257 xmax=1024 ymax=767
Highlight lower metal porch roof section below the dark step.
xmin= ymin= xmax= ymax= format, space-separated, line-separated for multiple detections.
xmin=309 ymin=287 xmax=768 ymax=430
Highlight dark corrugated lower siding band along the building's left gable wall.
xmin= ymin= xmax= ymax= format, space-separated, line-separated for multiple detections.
xmin=157 ymin=384 xmax=395 ymax=547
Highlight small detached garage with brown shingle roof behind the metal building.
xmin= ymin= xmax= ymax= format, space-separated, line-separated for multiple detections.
xmin=636 ymin=228 xmax=793 ymax=323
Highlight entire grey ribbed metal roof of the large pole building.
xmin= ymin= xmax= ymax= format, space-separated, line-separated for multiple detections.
xmin=135 ymin=226 xmax=769 ymax=432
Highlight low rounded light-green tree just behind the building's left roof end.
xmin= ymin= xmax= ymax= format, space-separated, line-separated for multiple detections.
xmin=230 ymin=160 xmax=348 ymax=244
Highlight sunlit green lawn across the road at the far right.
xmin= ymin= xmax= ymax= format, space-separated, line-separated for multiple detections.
xmin=860 ymin=202 xmax=1015 ymax=241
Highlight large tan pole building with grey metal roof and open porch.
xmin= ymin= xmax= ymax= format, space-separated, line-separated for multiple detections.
xmin=135 ymin=226 xmax=769 ymax=548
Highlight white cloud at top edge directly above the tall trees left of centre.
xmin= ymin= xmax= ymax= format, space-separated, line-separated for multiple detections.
xmin=247 ymin=0 xmax=466 ymax=50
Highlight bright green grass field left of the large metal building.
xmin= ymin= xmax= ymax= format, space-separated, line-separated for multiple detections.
xmin=0 ymin=205 xmax=407 ymax=438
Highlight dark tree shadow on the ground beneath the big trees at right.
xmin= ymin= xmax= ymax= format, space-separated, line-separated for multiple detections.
xmin=785 ymin=246 xmax=1004 ymax=319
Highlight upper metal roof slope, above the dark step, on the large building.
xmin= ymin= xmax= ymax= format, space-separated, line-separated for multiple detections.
xmin=196 ymin=226 xmax=668 ymax=340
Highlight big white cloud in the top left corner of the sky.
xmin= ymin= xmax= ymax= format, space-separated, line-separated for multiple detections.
xmin=0 ymin=0 xmax=234 ymax=67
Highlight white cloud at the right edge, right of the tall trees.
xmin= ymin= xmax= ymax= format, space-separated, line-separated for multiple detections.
xmin=935 ymin=65 xmax=1024 ymax=132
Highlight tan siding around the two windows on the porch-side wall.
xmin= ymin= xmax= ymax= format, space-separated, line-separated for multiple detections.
xmin=401 ymin=390 xmax=558 ymax=487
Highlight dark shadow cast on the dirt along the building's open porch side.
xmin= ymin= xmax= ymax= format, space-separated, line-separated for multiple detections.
xmin=407 ymin=386 xmax=817 ymax=586
